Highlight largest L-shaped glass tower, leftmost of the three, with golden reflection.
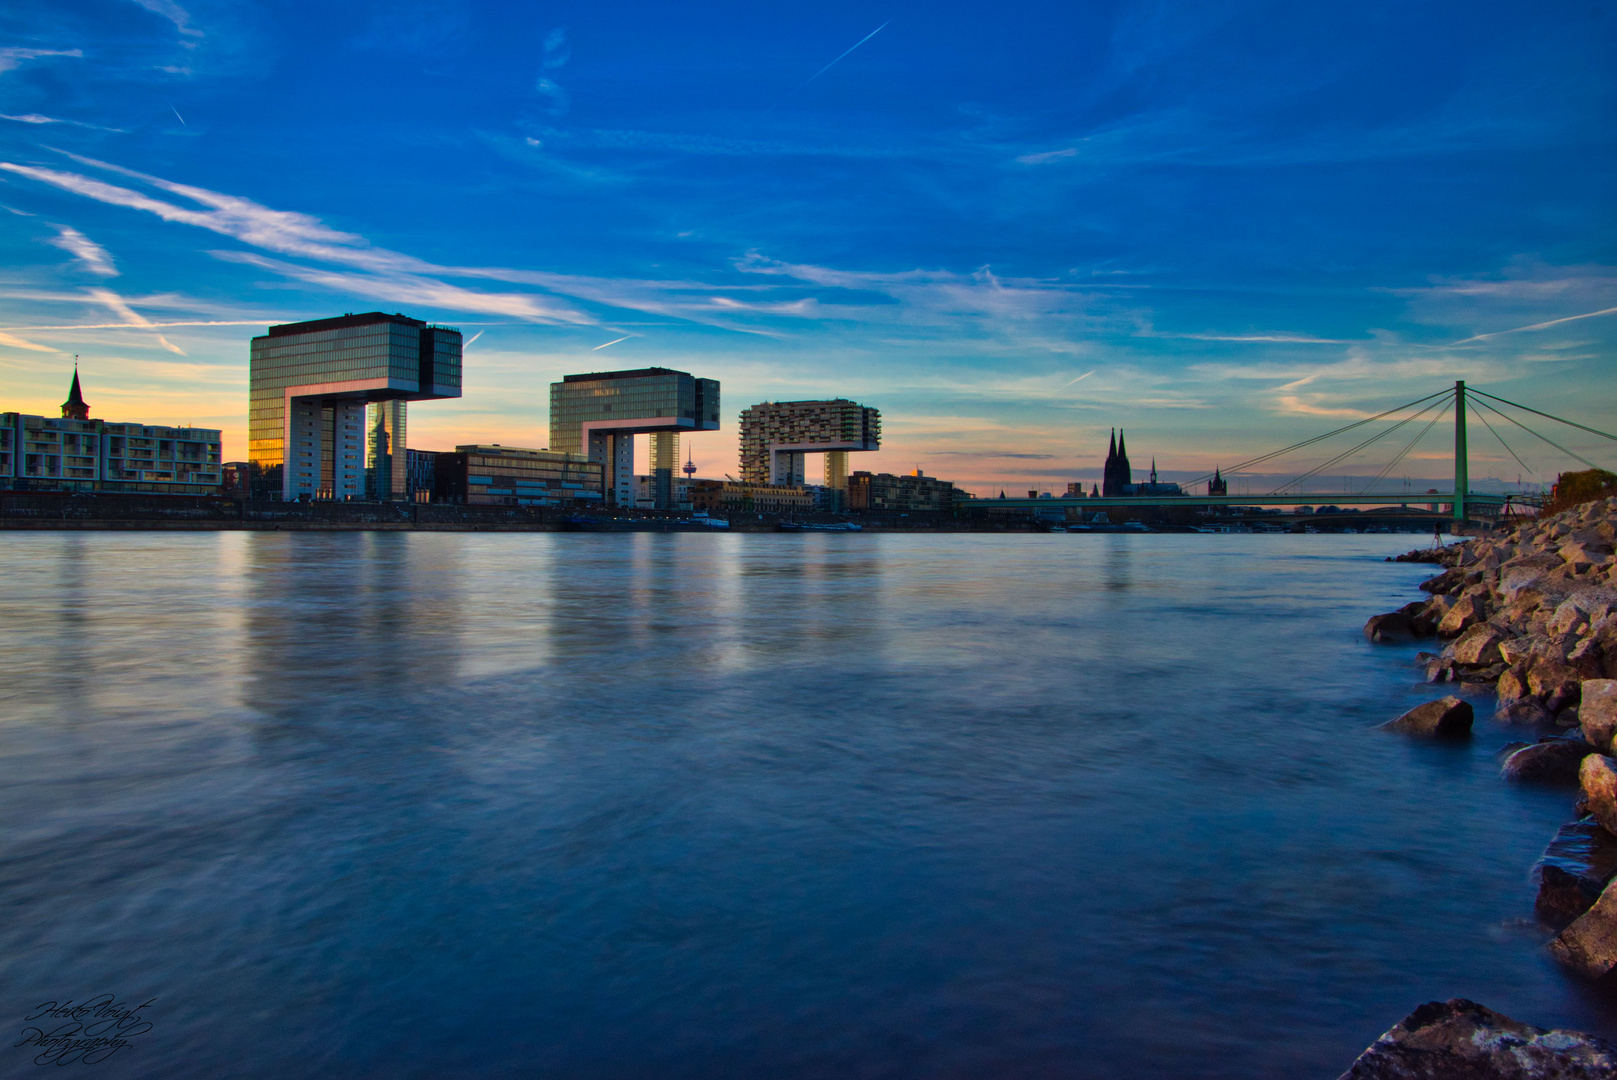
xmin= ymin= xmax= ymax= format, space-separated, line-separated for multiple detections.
xmin=247 ymin=312 xmax=461 ymax=500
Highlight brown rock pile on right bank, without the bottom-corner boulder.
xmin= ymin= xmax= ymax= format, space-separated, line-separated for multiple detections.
xmin=1365 ymin=498 xmax=1617 ymax=978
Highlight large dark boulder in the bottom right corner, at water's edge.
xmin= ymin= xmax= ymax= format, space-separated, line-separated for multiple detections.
xmin=1337 ymin=998 xmax=1617 ymax=1080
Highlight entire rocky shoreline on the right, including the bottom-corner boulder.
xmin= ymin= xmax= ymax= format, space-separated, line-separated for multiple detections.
xmin=1344 ymin=498 xmax=1617 ymax=1080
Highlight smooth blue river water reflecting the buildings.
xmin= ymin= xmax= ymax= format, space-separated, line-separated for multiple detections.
xmin=0 ymin=534 xmax=1617 ymax=1080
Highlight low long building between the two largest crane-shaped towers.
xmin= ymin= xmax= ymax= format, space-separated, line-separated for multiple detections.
xmin=433 ymin=445 xmax=606 ymax=506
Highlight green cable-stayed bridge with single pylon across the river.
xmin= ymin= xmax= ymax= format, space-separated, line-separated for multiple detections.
xmin=967 ymin=380 xmax=1617 ymax=521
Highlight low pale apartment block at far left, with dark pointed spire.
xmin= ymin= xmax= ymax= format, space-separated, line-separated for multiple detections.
xmin=0 ymin=372 xmax=222 ymax=495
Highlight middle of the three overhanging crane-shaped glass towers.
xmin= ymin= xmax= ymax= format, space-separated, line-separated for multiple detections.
xmin=550 ymin=367 xmax=718 ymax=509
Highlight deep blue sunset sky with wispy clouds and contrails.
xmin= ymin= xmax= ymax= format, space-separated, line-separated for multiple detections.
xmin=0 ymin=0 xmax=1617 ymax=491
